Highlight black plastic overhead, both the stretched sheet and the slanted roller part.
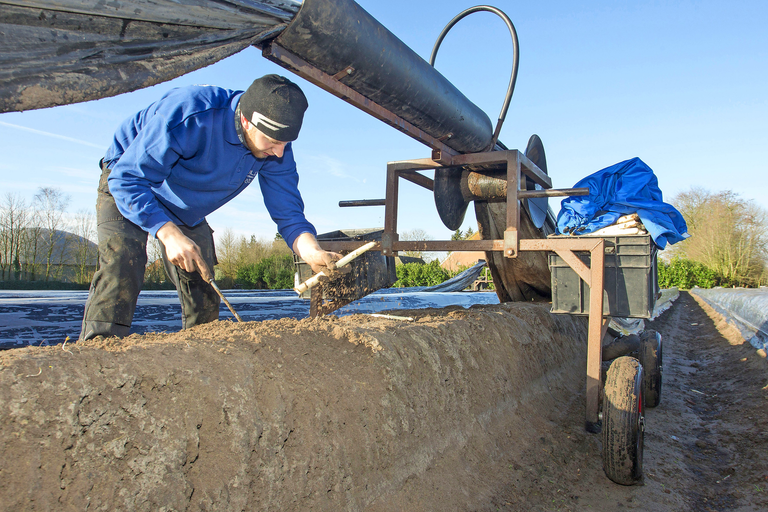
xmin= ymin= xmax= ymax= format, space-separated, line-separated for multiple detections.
xmin=0 ymin=0 xmax=493 ymax=153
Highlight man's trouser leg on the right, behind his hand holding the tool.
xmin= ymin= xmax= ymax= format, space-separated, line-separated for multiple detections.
xmin=160 ymin=221 xmax=221 ymax=329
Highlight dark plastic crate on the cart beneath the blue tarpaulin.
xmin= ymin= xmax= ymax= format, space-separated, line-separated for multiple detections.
xmin=549 ymin=235 xmax=659 ymax=318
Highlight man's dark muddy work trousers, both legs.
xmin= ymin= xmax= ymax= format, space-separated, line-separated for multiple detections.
xmin=80 ymin=160 xmax=221 ymax=340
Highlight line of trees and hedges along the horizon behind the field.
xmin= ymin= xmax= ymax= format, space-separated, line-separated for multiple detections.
xmin=9 ymin=187 xmax=756 ymax=289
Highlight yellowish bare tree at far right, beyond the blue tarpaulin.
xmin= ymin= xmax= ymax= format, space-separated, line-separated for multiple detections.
xmin=672 ymin=187 xmax=768 ymax=286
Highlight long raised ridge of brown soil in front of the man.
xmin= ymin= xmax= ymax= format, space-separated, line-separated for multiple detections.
xmin=0 ymin=303 xmax=586 ymax=511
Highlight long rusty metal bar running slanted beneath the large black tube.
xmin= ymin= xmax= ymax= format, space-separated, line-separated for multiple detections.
xmin=262 ymin=42 xmax=458 ymax=156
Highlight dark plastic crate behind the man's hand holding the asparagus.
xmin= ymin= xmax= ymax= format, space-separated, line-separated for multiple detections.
xmin=294 ymin=228 xmax=397 ymax=302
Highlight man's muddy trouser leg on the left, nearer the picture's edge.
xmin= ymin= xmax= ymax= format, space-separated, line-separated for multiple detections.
xmin=80 ymin=162 xmax=147 ymax=340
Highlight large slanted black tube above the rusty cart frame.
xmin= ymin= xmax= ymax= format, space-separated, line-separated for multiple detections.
xmin=276 ymin=0 xmax=493 ymax=153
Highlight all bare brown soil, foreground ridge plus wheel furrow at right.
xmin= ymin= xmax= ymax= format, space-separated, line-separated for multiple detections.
xmin=0 ymin=293 xmax=768 ymax=511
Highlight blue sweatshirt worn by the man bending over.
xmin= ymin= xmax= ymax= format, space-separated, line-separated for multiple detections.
xmin=104 ymin=86 xmax=317 ymax=247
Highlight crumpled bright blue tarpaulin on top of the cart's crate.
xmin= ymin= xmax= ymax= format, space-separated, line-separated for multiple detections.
xmin=557 ymin=158 xmax=689 ymax=249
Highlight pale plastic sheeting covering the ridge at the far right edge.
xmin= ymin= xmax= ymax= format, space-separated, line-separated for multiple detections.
xmin=691 ymin=287 xmax=768 ymax=350
